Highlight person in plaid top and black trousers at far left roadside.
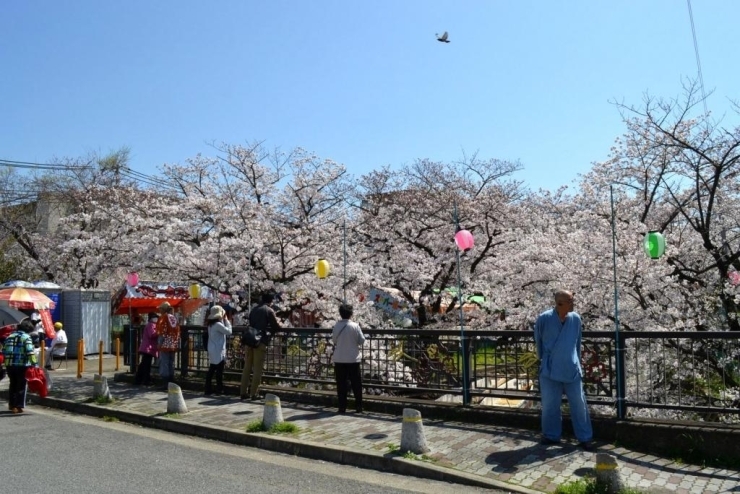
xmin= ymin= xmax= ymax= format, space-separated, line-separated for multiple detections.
xmin=3 ymin=319 xmax=38 ymax=413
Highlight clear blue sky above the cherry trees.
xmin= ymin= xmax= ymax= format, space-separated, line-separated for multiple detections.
xmin=0 ymin=0 xmax=740 ymax=189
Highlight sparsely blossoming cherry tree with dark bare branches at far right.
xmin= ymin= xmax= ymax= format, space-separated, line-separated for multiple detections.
xmin=605 ymin=83 xmax=740 ymax=331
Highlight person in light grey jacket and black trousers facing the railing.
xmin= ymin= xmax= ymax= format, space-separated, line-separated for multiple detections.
xmin=331 ymin=304 xmax=365 ymax=414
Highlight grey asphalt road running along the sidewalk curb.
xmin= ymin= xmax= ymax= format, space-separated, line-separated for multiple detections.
xmin=0 ymin=404 xmax=502 ymax=494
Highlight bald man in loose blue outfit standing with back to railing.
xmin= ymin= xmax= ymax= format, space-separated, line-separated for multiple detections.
xmin=534 ymin=290 xmax=593 ymax=450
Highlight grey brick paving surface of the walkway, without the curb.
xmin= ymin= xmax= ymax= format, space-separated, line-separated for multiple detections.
xmin=0 ymin=372 xmax=740 ymax=494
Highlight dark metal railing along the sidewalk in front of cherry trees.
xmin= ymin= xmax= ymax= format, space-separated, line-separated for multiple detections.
xmin=123 ymin=326 xmax=740 ymax=420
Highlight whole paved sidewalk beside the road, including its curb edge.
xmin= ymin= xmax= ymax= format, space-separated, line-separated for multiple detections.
xmin=0 ymin=359 xmax=740 ymax=494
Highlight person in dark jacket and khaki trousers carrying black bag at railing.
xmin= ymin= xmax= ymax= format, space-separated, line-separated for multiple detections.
xmin=240 ymin=293 xmax=281 ymax=400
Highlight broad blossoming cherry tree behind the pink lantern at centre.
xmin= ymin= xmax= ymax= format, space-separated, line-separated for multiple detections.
xmin=355 ymin=156 xmax=521 ymax=325
